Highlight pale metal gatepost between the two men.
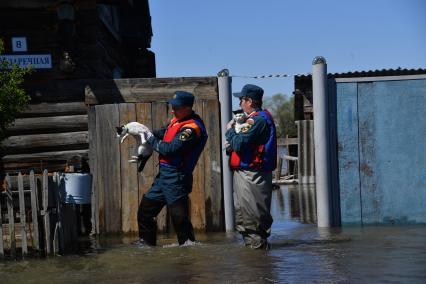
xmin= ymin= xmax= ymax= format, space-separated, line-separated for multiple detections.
xmin=217 ymin=69 xmax=234 ymax=232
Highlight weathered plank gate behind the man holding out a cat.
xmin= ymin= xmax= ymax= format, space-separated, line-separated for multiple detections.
xmin=86 ymin=77 xmax=223 ymax=233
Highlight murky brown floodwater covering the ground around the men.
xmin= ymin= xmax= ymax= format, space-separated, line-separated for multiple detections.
xmin=0 ymin=186 xmax=426 ymax=283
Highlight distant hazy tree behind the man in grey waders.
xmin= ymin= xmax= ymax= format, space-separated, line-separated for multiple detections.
xmin=264 ymin=94 xmax=297 ymax=137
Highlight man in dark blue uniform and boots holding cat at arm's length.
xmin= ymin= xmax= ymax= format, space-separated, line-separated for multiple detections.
xmin=138 ymin=91 xmax=207 ymax=246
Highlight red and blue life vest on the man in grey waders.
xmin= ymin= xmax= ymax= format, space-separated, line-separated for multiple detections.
xmin=229 ymin=110 xmax=277 ymax=171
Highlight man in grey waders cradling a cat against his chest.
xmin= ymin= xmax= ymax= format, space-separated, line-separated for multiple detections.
xmin=225 ymin=84 xmax=277 ymax=249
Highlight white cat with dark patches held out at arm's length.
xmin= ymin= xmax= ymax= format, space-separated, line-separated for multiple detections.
xmin=116 ymin=122 xmax=153 ymax=172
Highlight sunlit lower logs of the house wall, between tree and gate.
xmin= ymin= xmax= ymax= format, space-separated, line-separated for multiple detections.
xmin=0 ymin=102 xmax=89 ymax=173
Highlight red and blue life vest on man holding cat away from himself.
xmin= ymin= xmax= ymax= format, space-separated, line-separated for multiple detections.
xmin=159 ymin=117 xmax=207 ymax=172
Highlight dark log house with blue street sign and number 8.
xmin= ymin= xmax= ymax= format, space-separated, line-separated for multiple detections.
xmin=0 ymin=0 xmax=156 ymax=174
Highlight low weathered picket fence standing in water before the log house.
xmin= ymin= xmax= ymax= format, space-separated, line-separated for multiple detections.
xmin=0 ymin=170 xmax=78 ymax=258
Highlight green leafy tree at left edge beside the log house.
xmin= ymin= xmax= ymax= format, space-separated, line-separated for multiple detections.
xmin=0 ymin=39 xmax=31 ymax=141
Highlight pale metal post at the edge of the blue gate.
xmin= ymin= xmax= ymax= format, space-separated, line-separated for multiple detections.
xmin=312 ymin=56 xmax=332 ymax=227
